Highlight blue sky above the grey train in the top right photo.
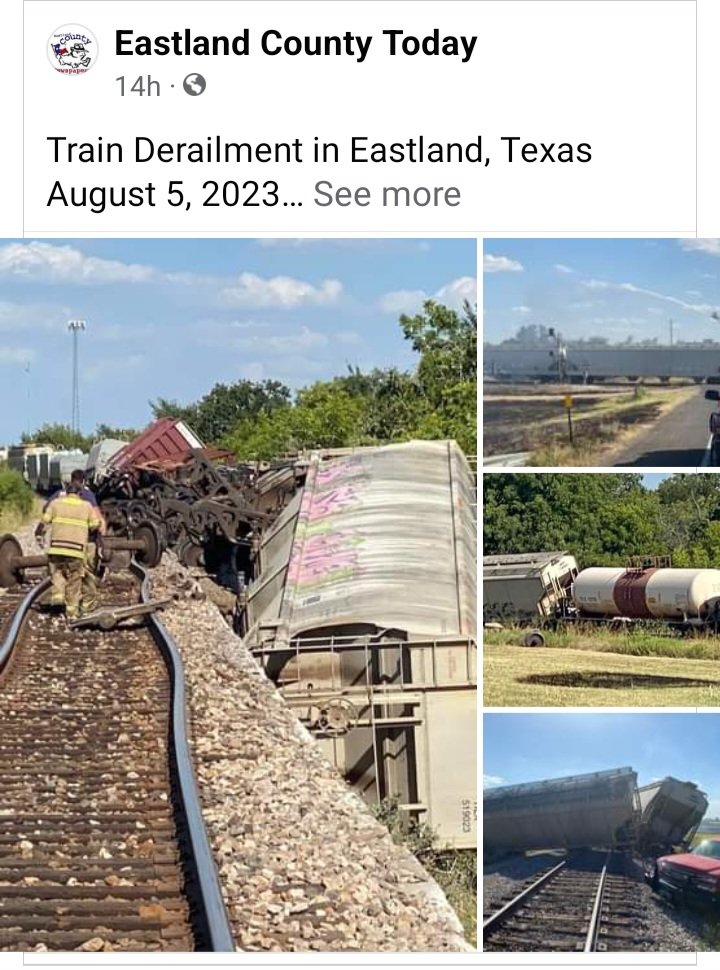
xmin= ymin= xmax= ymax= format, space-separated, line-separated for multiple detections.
xmin=483 ymin=239 xmax=720 ymax=343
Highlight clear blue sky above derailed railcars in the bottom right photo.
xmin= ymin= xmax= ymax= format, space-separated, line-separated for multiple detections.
xmin=483 ymin=712 xmax=720 ymax=816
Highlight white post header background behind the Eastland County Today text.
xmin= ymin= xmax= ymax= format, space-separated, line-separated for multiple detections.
xmin=15 ymin=0 xmax=695 ymax=235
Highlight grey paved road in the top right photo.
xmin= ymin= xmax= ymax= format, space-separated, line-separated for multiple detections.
xmin=615 ymin=387 xmax=715 ymax=468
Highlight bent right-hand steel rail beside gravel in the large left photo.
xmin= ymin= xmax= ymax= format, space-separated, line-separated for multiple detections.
xmin=130 ymin=559 xmax=235 ymax=952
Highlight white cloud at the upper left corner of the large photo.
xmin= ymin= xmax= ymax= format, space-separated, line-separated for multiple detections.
xmin=0 ymin=242 xmax=158 ymax=283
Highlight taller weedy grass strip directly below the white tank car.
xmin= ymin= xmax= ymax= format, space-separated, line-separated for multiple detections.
xmin=483 ymin=626 xmax=720 ymax=660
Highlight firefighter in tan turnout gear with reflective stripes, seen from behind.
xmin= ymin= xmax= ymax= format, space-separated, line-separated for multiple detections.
xmin=35 ymin=481 xmax=103 ymax=619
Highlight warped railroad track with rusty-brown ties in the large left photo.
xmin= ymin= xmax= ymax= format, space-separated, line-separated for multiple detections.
xmin=0 ymin=563 xmax=234 ymax=950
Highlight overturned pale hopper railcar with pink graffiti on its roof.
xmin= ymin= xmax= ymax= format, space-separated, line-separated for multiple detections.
xmin=243 ymin=441 xmax=477 ymax=848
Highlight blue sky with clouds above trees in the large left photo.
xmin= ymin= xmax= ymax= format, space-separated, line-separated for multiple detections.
xmin=0 ymin=239 xmax=477 ymax=443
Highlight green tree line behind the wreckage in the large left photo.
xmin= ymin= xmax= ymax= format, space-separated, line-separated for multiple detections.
xmin=23 ymin=300 xmax=477 ymax=459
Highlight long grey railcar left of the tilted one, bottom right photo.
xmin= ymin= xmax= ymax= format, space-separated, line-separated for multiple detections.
xmin=483 ymin=768 xmax=641 ymax=852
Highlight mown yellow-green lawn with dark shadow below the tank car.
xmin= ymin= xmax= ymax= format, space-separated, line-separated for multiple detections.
xmin=483 ymin=642 xmax=720 ymax=707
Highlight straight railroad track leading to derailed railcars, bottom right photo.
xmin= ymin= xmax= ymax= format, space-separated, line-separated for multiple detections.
xmin=483 ymin=852 xmax=650 ymax=952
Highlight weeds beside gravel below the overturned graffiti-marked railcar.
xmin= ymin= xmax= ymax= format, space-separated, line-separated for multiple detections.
xmin=372 ymin=798 xmax=477 ymax=947
